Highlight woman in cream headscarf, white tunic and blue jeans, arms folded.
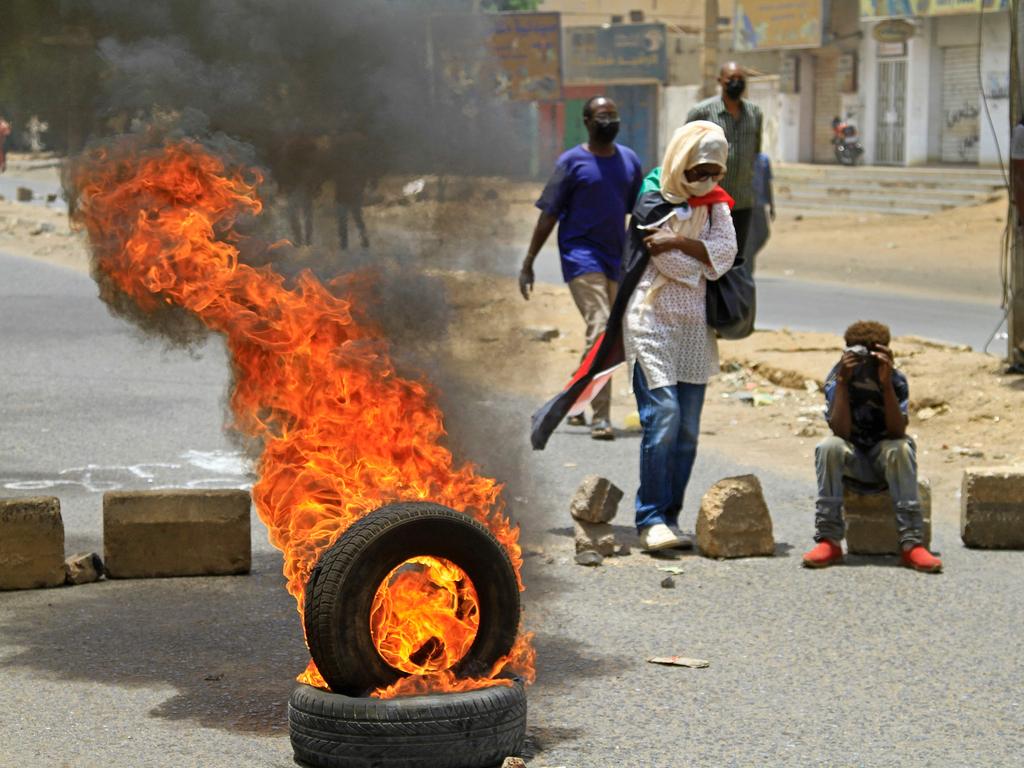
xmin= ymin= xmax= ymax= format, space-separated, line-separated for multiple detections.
xmin=623 ymin=121 xmax=736 ymax=550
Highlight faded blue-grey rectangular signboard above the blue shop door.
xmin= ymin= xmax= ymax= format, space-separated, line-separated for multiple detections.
xmin=562 ymin=24 xmax=669 ymax=83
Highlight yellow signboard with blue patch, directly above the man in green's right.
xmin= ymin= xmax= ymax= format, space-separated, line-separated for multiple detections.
xmin=732 ymin=0 xmax=822 ymax=50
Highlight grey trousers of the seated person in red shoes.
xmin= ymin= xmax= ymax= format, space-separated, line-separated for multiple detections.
xmin=814 ymin=435 xmax=924 ymax=549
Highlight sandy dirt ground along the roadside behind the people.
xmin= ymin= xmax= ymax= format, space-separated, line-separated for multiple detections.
xmin=0 ymin=155 xmax=1024 ymax=519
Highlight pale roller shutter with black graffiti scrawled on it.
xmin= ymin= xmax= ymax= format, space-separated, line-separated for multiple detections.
xmin=942 ymin=45 xmax=981 ymax=163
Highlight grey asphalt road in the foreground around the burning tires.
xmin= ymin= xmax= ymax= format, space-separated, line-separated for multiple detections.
xmin=0 ymin=249 xmax=1024 ymax=768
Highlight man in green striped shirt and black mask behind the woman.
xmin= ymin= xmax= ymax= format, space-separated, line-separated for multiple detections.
xmin=686 ymin=61 xmax=764 ymax=254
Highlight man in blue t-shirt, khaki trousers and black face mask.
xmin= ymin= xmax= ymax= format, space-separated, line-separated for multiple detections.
xmin=519 ymin=96 xmax=643 ymax=440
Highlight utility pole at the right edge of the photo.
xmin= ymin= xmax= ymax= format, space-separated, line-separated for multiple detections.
xmin=1007 ymin=0 xmax=1024 ymax=370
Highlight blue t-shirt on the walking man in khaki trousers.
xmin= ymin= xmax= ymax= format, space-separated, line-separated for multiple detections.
xmin=537 ymin=144 xmax=643 ymax=283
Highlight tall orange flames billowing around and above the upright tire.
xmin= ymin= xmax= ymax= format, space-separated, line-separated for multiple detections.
xmin=73 ymin=140 xmax=532 ymax=697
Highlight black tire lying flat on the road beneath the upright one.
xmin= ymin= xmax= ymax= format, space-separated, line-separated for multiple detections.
xmin=288 ymin=679 xmax=526 ymax=768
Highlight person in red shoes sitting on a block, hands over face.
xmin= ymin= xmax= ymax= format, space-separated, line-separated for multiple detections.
xmin=804 ymin=321 xmax=942 ymax=573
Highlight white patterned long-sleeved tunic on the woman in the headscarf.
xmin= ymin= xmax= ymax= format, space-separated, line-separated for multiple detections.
xmin=623 ymin=203 xmax=736 ymax=389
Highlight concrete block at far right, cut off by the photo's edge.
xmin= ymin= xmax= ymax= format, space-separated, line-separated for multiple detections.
xmin=961 ymin=467 xmax=1024 ymax=549
